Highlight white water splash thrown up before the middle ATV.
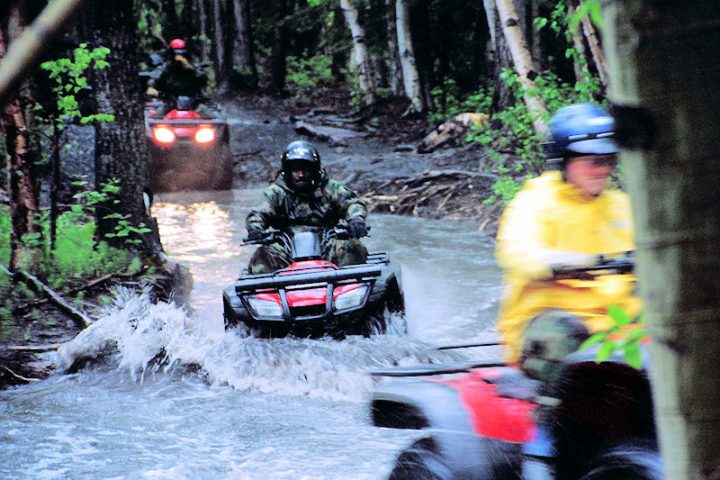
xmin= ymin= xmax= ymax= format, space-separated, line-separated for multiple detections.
xmin=56 ymin=289 xmax=462 ymax=402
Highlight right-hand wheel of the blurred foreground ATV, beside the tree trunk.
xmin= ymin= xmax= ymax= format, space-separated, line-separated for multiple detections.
xmin=581 ymin=441 xmax=663 ymax=480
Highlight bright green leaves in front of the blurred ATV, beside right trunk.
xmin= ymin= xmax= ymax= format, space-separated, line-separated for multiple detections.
xmin=580 ymin=305 xmax=648 ymax=369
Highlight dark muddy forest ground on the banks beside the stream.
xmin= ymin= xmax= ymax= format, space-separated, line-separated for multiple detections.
xmin=0 ymin=91 xmax=506 ymax=388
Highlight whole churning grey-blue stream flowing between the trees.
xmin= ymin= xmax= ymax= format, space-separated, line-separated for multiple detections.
xmin=0 ymin=190 xmax=500 ymax=480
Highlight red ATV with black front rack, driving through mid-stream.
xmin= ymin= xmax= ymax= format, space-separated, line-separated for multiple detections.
xmin=223 ymin=226 xmax=406 ymax=339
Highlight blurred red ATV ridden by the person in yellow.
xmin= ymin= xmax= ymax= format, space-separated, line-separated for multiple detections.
xmin=370 ymin=253 xmax=662 ymax=480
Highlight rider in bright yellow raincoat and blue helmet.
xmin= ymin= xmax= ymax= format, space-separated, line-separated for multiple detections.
xmin=496 ymin=103 xmax=641 ymax=377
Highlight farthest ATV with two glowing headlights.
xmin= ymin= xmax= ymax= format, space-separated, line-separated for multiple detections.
xmin=145 ymin=96 xmax=233 ymax=192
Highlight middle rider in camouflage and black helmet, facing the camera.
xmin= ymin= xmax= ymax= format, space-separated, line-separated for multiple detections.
xmin=246 ymin=141 xmax=368 ymax=274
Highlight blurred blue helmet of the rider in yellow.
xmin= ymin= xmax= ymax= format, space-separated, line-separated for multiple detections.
xmin=548 ymin=103 xmax=618 ymax=161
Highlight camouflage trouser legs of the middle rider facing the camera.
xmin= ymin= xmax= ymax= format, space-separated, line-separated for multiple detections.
xmin=248 ymin=239 xmax=368 ymax=275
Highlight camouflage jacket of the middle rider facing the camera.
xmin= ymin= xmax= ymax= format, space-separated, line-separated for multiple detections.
xmin=246 ymin=170 xmax=367 ymax=230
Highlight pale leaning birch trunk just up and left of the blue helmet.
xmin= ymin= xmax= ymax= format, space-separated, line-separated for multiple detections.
xmin=495 ymin=0 xmax=549 ymax=136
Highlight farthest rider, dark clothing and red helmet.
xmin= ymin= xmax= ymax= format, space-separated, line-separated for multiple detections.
xmin=147 ymin=38 xmax=214 ymax=118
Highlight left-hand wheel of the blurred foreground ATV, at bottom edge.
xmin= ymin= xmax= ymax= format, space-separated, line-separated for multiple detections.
xmin=388 ymin=438 xmax=453 ymax=480
